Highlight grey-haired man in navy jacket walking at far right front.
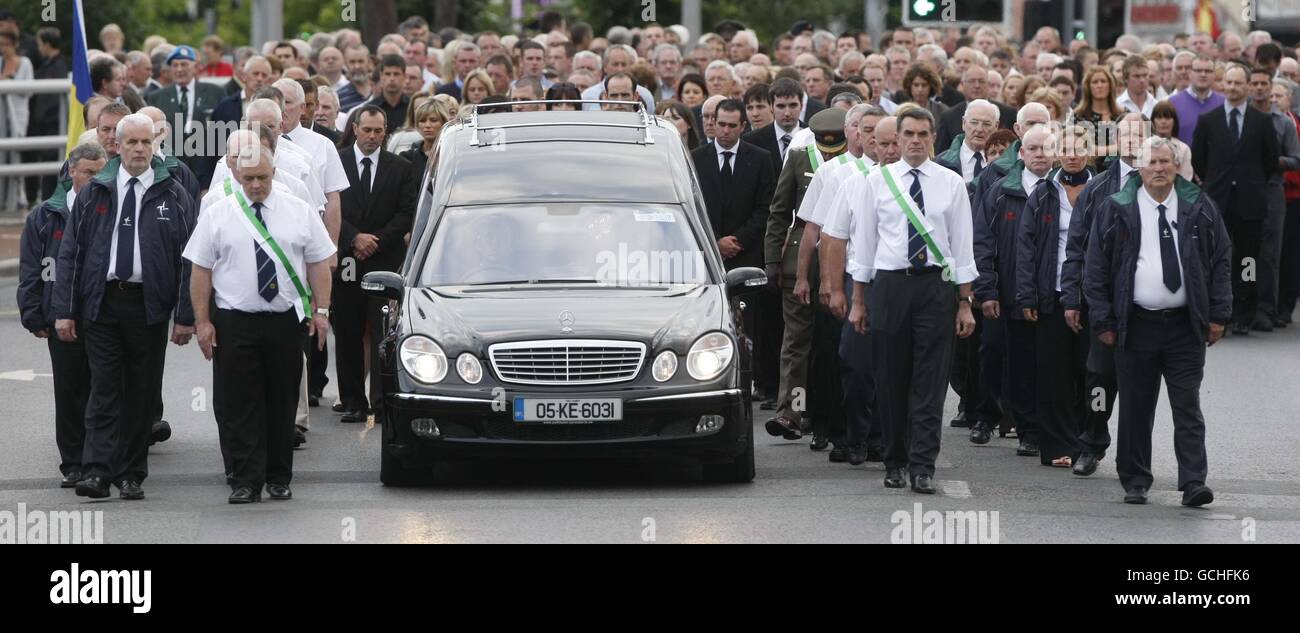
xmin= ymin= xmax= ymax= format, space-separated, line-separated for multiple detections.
xmin=1084 ymin=136 xmax=1234 ymax=507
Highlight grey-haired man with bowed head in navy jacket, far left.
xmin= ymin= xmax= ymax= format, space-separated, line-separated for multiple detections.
xmin=18 ymin=140 xmax=108 ymax=487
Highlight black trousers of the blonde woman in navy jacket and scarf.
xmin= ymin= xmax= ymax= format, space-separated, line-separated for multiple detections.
xmin=1034 ymin=304 xmax=1088 ymax=464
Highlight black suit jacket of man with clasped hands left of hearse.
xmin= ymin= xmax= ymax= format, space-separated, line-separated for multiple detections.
xmin=335 ymin=146 xmax=419 ymax=274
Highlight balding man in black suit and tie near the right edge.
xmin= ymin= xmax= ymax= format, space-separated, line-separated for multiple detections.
xmin=1192 ymin=64 xmax=1278 ymax=334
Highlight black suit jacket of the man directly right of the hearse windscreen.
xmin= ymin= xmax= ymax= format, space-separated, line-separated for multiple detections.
xmin=690 ymin=140 xmax=776 ymax=270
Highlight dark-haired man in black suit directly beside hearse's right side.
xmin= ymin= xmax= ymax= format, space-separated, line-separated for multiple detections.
xmin=690 ymin=98 xmax=774 ymax=405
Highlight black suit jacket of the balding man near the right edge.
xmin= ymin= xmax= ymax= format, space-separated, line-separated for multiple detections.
xmin=1192 ymin=105 xmax=1278 ymax=220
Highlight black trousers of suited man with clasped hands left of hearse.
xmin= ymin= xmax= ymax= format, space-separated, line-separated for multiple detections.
xmin=330 ymin=278 xmax=384 ymax=412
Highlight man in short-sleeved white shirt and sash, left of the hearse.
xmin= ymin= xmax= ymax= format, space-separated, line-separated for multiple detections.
xmin=185 ymin=146 xmax=334 ymax=504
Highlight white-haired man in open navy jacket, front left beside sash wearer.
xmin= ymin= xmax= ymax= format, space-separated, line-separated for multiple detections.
xmin=52 ymin=114 xmax=195 ymax=500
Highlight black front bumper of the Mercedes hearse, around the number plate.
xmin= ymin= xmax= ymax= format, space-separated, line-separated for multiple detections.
xmin=384 ymin=385 xmax=753 ymax=468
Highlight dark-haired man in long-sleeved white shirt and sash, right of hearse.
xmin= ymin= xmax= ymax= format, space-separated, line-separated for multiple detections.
xmin=846 ymin=109 xmax=978 ymax=494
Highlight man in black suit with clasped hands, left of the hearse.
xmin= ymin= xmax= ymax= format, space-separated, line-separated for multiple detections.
xmin=332 ymin=105 xmax=417 ymax=422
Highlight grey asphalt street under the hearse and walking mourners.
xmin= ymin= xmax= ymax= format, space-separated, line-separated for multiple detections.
xmin=0 ymin=279 xmax=1300 ymax=543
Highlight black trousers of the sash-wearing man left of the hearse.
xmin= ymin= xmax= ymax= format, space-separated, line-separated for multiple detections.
xmin=212 ymin=309 xmax=306 ymax=490
